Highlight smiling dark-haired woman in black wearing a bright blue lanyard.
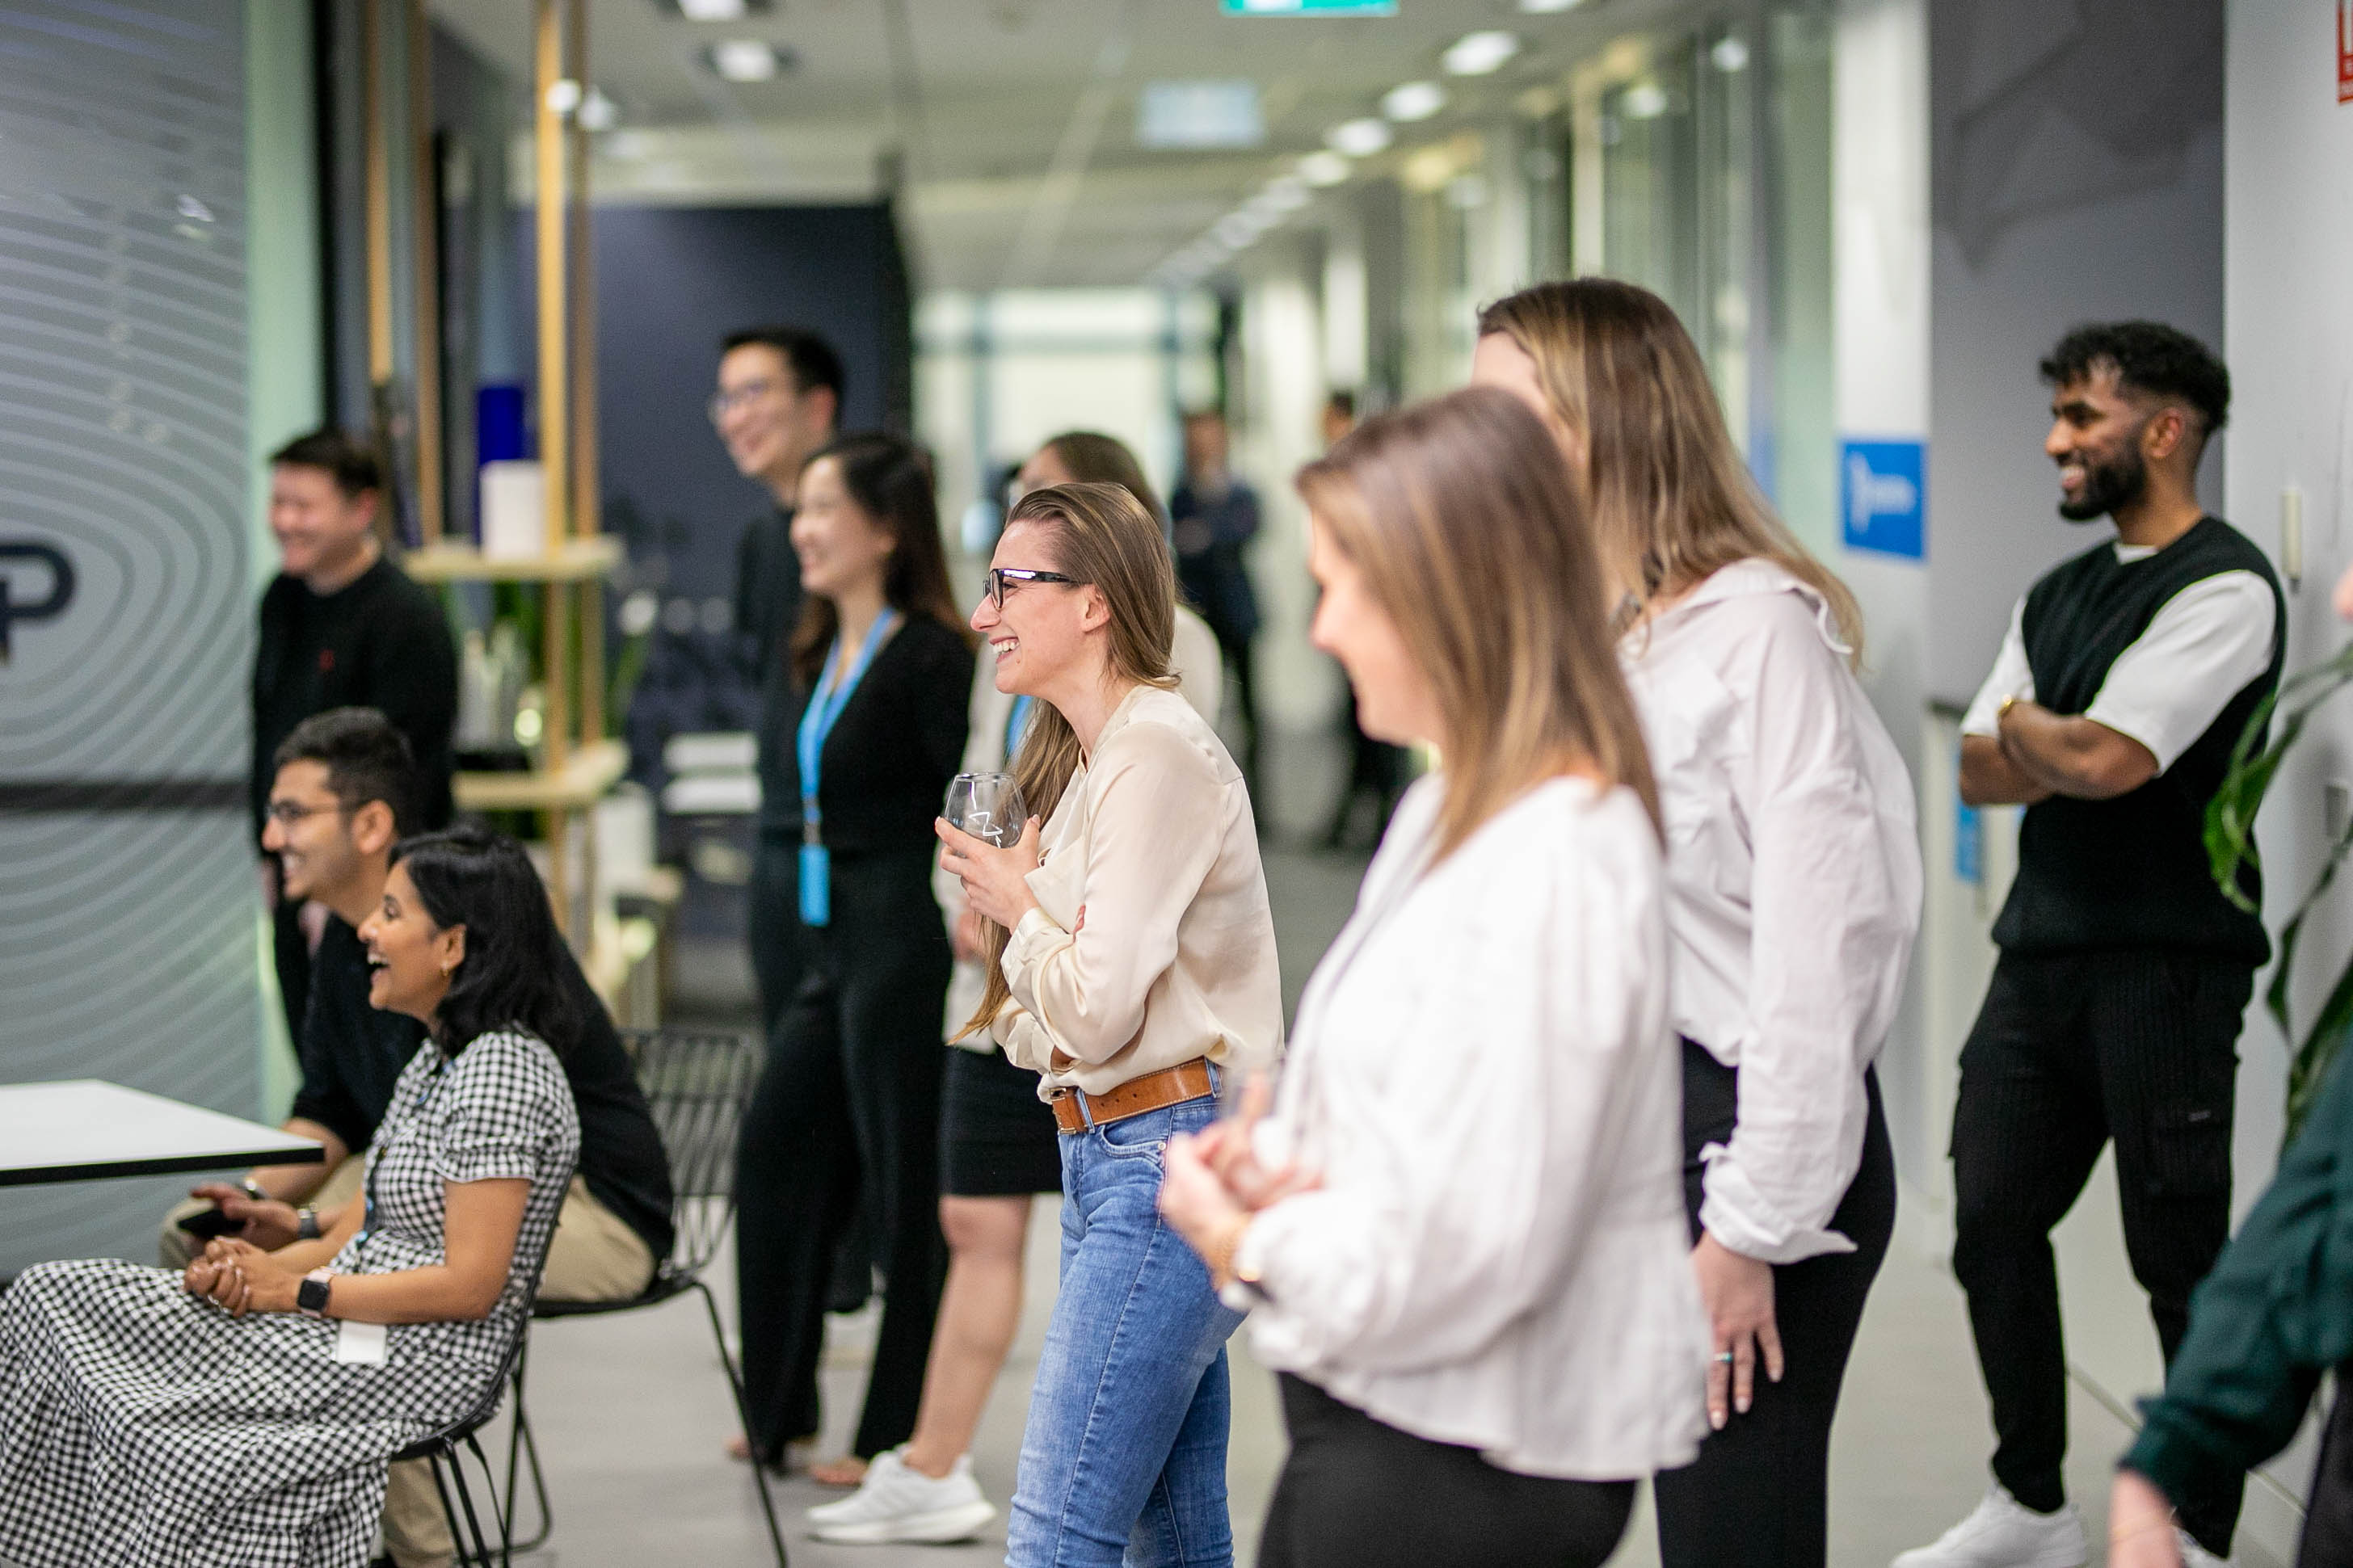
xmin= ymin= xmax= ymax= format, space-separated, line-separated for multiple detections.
xmin=736 ymin=435 xmax=972 ymax=1483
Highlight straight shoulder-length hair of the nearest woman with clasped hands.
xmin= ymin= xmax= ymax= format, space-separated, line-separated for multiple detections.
xmin=1297 ymin=388 xmax=1659 ymax=858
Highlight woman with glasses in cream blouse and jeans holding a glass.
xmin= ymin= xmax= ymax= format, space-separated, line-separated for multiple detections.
xmin=939 ymin=484 xmax=1282 ymax=1568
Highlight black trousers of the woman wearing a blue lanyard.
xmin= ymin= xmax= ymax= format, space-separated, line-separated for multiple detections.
xmin=736 ymin=849 xmax=950 ymax=1460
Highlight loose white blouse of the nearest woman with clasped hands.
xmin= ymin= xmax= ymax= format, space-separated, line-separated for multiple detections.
xmin=1235 ymin=773 xmax=1708 ymax=1478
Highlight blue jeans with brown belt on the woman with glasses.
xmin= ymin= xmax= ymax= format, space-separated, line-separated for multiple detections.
xmin=1004 ymin=1095 xmax=1243 ymax=1568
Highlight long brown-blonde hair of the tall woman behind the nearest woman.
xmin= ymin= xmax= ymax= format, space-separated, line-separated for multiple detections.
xmin=1478 ymin=277 xmax=1863 ymax=667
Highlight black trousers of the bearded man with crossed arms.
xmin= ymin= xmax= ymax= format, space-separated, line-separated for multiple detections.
xmin=1953 ymin=950 xmax=2254 ymax=1549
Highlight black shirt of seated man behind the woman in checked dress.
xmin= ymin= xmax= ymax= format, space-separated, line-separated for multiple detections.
xmin=292 ymin=917 xmax=671 ymax=1263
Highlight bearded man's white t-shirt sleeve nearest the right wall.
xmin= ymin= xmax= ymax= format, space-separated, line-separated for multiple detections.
xmin=2098 ymin=571 xmax=2278 ymax=773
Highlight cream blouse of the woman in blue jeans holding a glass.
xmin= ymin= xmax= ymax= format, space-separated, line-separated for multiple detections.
xmin=991 ymin=687 xmax=1282 ymax=1095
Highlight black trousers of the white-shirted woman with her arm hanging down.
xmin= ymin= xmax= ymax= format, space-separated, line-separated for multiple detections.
xmin=1654 ymin=1039 xmax=1896 ymax=1568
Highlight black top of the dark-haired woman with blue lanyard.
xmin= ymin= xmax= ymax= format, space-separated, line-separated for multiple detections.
xmin=790 ymin=616 xmax=972 ymax=858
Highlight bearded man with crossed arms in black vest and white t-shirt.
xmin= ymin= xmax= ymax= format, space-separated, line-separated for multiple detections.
xmin=1896 ymin=322 xmax=2285 ymax=1568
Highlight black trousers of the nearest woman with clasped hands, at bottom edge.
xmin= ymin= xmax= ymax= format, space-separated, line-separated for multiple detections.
xmin=1259 ymin=1373 xmax=1633 ymax=1568
